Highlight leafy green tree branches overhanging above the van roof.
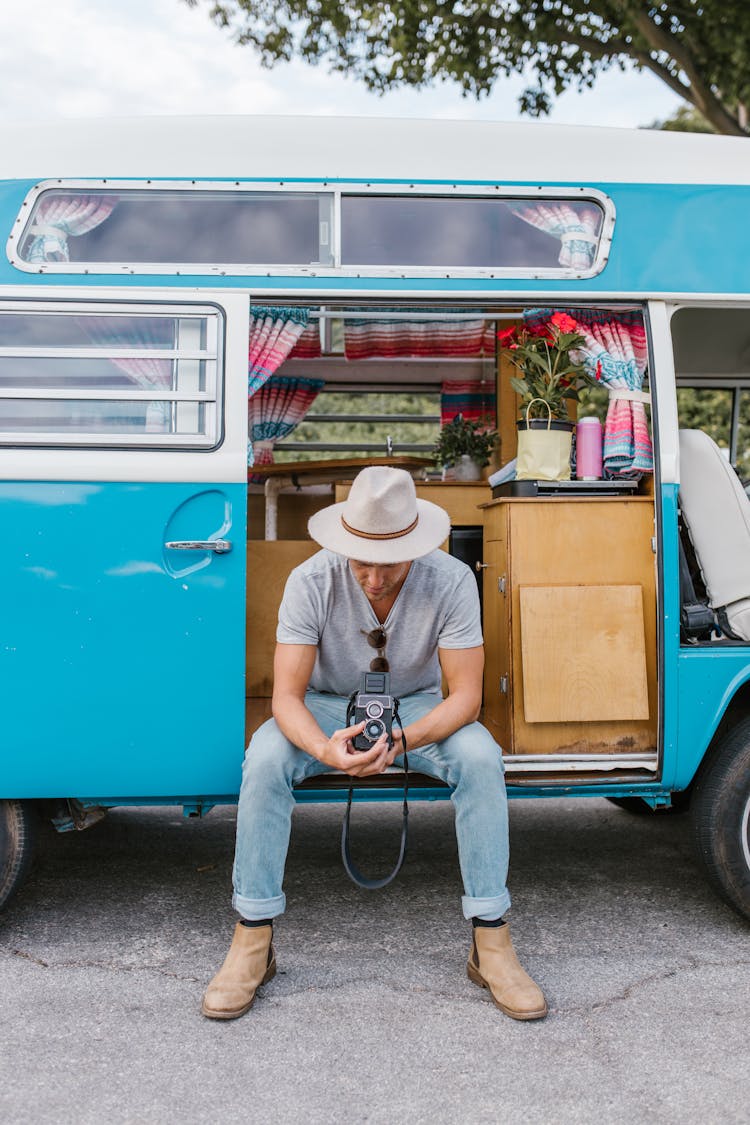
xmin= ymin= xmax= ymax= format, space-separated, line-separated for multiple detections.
xmin=186 ymin=0 xmax=750 ymax=136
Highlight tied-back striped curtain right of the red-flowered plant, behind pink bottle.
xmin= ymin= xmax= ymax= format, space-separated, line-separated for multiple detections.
xmin=524 ymin=308 xmax=653 ymax=479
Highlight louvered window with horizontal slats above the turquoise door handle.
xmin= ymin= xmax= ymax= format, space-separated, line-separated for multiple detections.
xmin=0 ymin=302 xmax=224 ymax=448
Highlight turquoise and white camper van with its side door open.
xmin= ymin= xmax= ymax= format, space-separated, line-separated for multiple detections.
xmin=0 ymin=117 xmax=750 ymax=917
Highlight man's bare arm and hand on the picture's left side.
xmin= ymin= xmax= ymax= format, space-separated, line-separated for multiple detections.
xmin=271 ymin=644 xmax=395 ymax=777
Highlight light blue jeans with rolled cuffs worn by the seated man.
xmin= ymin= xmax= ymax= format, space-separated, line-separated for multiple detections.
xmin=232 ymin=692 xmax=510 ymax=920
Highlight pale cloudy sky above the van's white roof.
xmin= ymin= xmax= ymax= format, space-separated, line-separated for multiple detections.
xmin=0 ymin=0 xmax=680 ymax=127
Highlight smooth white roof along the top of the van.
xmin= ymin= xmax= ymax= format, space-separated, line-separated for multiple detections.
xmin=0 ymin=116 xmax=750 ymax=185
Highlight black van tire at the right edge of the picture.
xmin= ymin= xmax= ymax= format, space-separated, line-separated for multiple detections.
xmin=690 ymin=718 xmax=750 ymax=918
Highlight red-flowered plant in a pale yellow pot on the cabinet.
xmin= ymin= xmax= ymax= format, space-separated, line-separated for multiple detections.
xmin=498 ymin=313 xmax=600 ymax=480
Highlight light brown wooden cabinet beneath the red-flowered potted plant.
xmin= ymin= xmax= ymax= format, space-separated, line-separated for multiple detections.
xmin=484 ymin=496 xmax=658 ymax=755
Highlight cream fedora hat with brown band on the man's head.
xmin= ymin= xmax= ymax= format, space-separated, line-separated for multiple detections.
xmin=307 ymin=465 xmax=451 ymax=564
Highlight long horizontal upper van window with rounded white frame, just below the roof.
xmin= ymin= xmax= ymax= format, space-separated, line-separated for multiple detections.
xmin=7 ymin=180 xmax=615 ymax=278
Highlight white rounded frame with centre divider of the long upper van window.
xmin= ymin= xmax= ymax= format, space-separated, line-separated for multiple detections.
xmin=6 ymin=179 xmax=616 ymax=280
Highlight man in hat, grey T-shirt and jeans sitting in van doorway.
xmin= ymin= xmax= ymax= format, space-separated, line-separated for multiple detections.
xmin=201 ymin=467 xmax=546 ymax=1019
